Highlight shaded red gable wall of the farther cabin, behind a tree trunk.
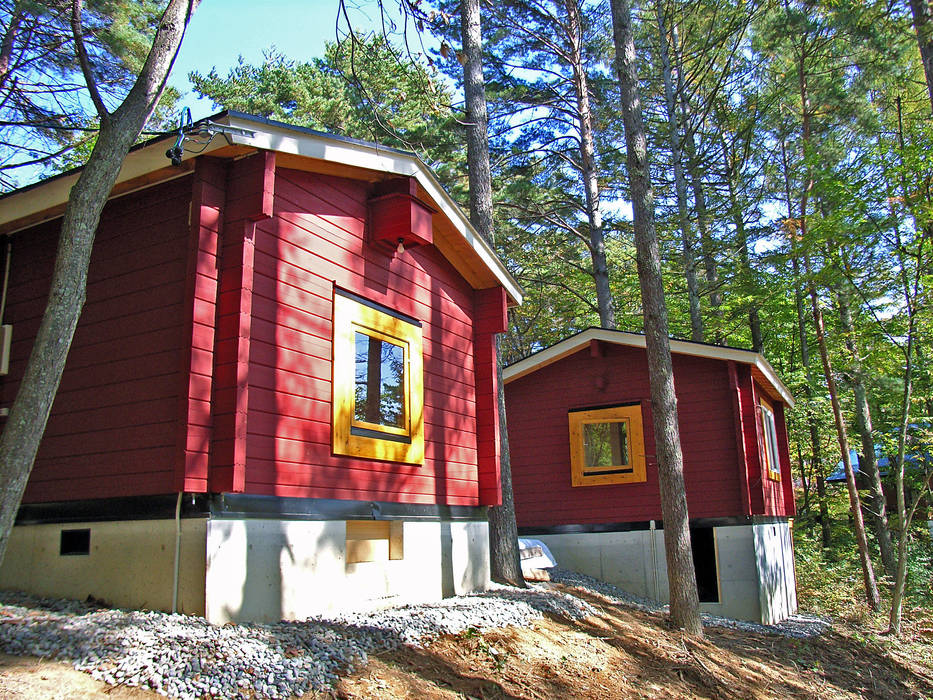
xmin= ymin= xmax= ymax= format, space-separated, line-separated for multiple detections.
xmin=506 ymin=343 xmax=792 ymax=527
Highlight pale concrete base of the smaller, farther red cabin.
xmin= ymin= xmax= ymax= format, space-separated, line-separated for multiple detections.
xmin=535 ymin=522 xmax=797 ymax=623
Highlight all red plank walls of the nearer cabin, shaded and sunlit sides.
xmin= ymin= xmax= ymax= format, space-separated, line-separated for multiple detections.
xmin=0 ymin=153 xmax=505 ymax=505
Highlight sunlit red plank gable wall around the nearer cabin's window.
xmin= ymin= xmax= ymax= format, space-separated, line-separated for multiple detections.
xmin=235 ymin=168 xmax=480 ymax=505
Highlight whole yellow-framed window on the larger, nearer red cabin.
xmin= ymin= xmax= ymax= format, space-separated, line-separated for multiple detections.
xmin=333 ymin=290 xmax=424 ymax=464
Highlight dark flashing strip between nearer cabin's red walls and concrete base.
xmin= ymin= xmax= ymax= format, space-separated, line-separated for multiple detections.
xmin=16 ymin=493 xmax=487 ymax=525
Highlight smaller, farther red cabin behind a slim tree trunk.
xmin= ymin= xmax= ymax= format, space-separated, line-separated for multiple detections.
xmin=504 ymin=328 xmax=796 ymax=622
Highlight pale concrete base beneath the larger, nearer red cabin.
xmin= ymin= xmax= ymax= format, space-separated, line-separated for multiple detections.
xmin=0 ymin=519 xmax=489 ymax=624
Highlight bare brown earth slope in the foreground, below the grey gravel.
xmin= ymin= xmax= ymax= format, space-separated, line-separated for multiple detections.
xmin=0 ymin=588 xmax=933 ymax=700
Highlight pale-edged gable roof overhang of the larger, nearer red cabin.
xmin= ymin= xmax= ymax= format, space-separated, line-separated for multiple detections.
xmin=0 ymin=110 xmax=522 ymax=304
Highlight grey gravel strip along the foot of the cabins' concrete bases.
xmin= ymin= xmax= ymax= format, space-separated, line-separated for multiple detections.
xmin=0 ymin=569 xmax=828 ymax=698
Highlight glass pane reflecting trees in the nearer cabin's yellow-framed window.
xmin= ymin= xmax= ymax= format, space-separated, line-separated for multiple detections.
xmin=353 ymin=331 xmax=405 ymax=428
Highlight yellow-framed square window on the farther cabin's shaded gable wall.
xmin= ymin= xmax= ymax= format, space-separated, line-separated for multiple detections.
xmin=569 ymin=404 xmax=647 ymax=486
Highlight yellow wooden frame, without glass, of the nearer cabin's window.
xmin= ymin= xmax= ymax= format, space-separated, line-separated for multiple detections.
xmin=332 ymin=289 xmax=424 ymax=464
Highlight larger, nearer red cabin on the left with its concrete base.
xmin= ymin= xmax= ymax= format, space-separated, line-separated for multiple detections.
xmin=0 ymin=112 xmax=521 ymax=622
